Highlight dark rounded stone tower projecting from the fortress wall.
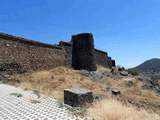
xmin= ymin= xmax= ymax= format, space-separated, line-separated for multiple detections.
xmin=72 ymin=33 xmax=97 ymax=71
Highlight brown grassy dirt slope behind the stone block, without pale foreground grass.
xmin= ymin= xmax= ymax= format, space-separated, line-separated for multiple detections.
xmin=8 ymin=67 xmax=160 ymax=120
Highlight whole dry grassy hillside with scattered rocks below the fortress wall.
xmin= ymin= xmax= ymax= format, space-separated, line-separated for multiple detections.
xmin=4 ymin=67 xmax=160 ymax=120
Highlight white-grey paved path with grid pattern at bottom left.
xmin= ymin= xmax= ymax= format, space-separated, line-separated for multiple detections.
xmin=0 ymin=84 xmax=85 ymax=120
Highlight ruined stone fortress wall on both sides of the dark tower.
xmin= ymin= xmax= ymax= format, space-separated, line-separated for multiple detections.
xmin=0 ymin=33 xmax=115 ymax=73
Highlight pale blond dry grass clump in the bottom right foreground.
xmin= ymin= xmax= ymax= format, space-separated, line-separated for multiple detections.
xmin=88 ymin=100 xmax=160 ymax=120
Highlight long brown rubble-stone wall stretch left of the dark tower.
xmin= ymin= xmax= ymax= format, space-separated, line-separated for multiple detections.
xmin=0 ymin=34 xmax=66 ymax=72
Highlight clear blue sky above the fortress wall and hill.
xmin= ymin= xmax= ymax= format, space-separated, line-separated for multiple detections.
xmin=0 ymin=0 xmax=160 ymax=67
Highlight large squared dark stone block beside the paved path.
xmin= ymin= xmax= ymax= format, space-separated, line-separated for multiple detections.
xmin=64 ymin=88 xmax=94 ymax=107
